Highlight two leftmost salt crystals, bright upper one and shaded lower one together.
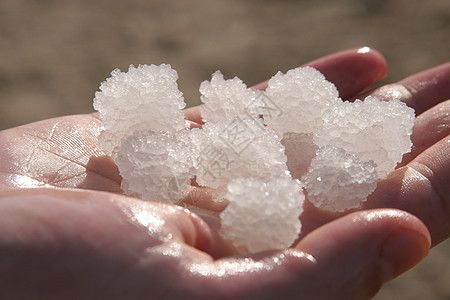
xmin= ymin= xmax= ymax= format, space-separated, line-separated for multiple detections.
xmin=94 ymin=64 xmax=192 ymax=203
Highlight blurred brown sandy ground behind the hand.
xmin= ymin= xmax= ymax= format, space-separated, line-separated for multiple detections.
xmin=0 ymin=0 xmax=450 ymax=300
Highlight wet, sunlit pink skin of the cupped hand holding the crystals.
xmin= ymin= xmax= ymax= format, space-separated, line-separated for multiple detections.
xmin=0 ymin=47 xmax=450 ymax=299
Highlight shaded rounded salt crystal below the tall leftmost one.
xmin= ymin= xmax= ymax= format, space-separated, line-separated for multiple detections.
xmin=116 ymin=129 xmax=198 ymax=203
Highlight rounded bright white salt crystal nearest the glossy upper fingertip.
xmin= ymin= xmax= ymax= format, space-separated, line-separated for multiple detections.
xmin=264 ymin=67 xmax=339 ymax=136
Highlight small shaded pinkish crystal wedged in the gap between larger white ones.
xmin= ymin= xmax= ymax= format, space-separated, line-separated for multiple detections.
xmin=281 ymin=132 xmax=319 ymax=179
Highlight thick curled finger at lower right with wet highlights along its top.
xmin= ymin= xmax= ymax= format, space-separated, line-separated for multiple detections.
xmin=186 ymin=210 xmax=430 ymax=299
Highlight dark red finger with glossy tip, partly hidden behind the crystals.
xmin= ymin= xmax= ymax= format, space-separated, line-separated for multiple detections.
xmin=185 ymin=47 xmax=386 ymax=124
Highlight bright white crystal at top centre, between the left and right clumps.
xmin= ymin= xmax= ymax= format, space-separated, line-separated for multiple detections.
xmin=200 ymin=71 xmax=262 ymax=122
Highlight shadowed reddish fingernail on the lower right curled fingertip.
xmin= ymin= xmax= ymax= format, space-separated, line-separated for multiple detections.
xmin=381 ymin=230 xmax=430 ymax=282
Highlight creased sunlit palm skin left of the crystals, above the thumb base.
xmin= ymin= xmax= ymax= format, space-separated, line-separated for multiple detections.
xmin=0 ymin=114 xmax=121 ymax=192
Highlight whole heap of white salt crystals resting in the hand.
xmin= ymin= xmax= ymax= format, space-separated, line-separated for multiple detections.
xmin=94 ymin=65 xmax=414 ymax=251
